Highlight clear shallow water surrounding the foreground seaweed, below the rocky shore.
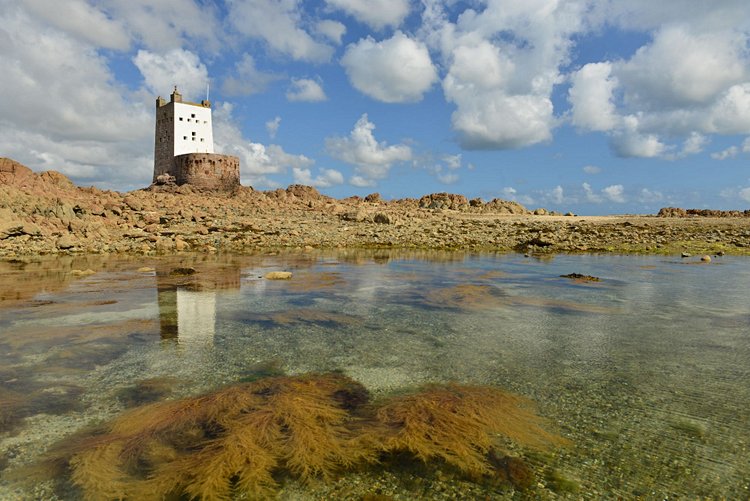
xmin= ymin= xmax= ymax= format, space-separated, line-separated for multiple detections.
xmin=0 ymin=252 xmax=750 ymax=499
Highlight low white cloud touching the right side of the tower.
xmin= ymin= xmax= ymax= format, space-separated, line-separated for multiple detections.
xmin=213 ymin=103 xmax=315 ymax=188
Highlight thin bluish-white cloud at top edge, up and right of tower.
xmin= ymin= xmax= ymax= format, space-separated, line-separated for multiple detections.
xmin=227 ymin=0 xmax=333 ymax=62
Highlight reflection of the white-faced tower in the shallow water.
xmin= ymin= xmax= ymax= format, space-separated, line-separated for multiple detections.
xmin=156 ymin=266 xmax=240 ymax=344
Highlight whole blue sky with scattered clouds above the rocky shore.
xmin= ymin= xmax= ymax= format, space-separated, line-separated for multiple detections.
xmin=0 ymin=0 xmax=750 ymax=214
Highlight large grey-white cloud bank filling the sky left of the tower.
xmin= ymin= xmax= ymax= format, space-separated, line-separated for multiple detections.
xmin=0 ymin=2 xmax=153 ymax=189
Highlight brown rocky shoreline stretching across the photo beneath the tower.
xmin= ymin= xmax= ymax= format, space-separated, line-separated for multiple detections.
xmin=0 ymin=158 xmax=750 ymax=260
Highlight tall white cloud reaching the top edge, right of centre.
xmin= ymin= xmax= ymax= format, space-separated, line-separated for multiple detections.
xmin=421 ymin=0 xmax=584 ymax=149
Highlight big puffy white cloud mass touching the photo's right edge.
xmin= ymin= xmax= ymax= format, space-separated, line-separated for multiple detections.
xmin=568 ymin=18 xmax=750 ymax=160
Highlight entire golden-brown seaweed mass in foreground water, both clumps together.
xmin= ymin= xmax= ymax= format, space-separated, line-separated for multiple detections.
xmin=44 ymin=373 xmax=563 ymax=500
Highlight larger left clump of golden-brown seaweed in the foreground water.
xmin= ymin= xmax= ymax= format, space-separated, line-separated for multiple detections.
xmin=49 ymin=374 xmax=377 ymax=500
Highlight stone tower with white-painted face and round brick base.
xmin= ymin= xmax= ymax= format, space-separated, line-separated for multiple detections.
xmin=153 ymin=87 xmax=240 ymax=190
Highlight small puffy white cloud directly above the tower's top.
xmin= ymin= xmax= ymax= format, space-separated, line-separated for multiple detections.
xmin=133 ymin=49 xmax=208 ymax=101
